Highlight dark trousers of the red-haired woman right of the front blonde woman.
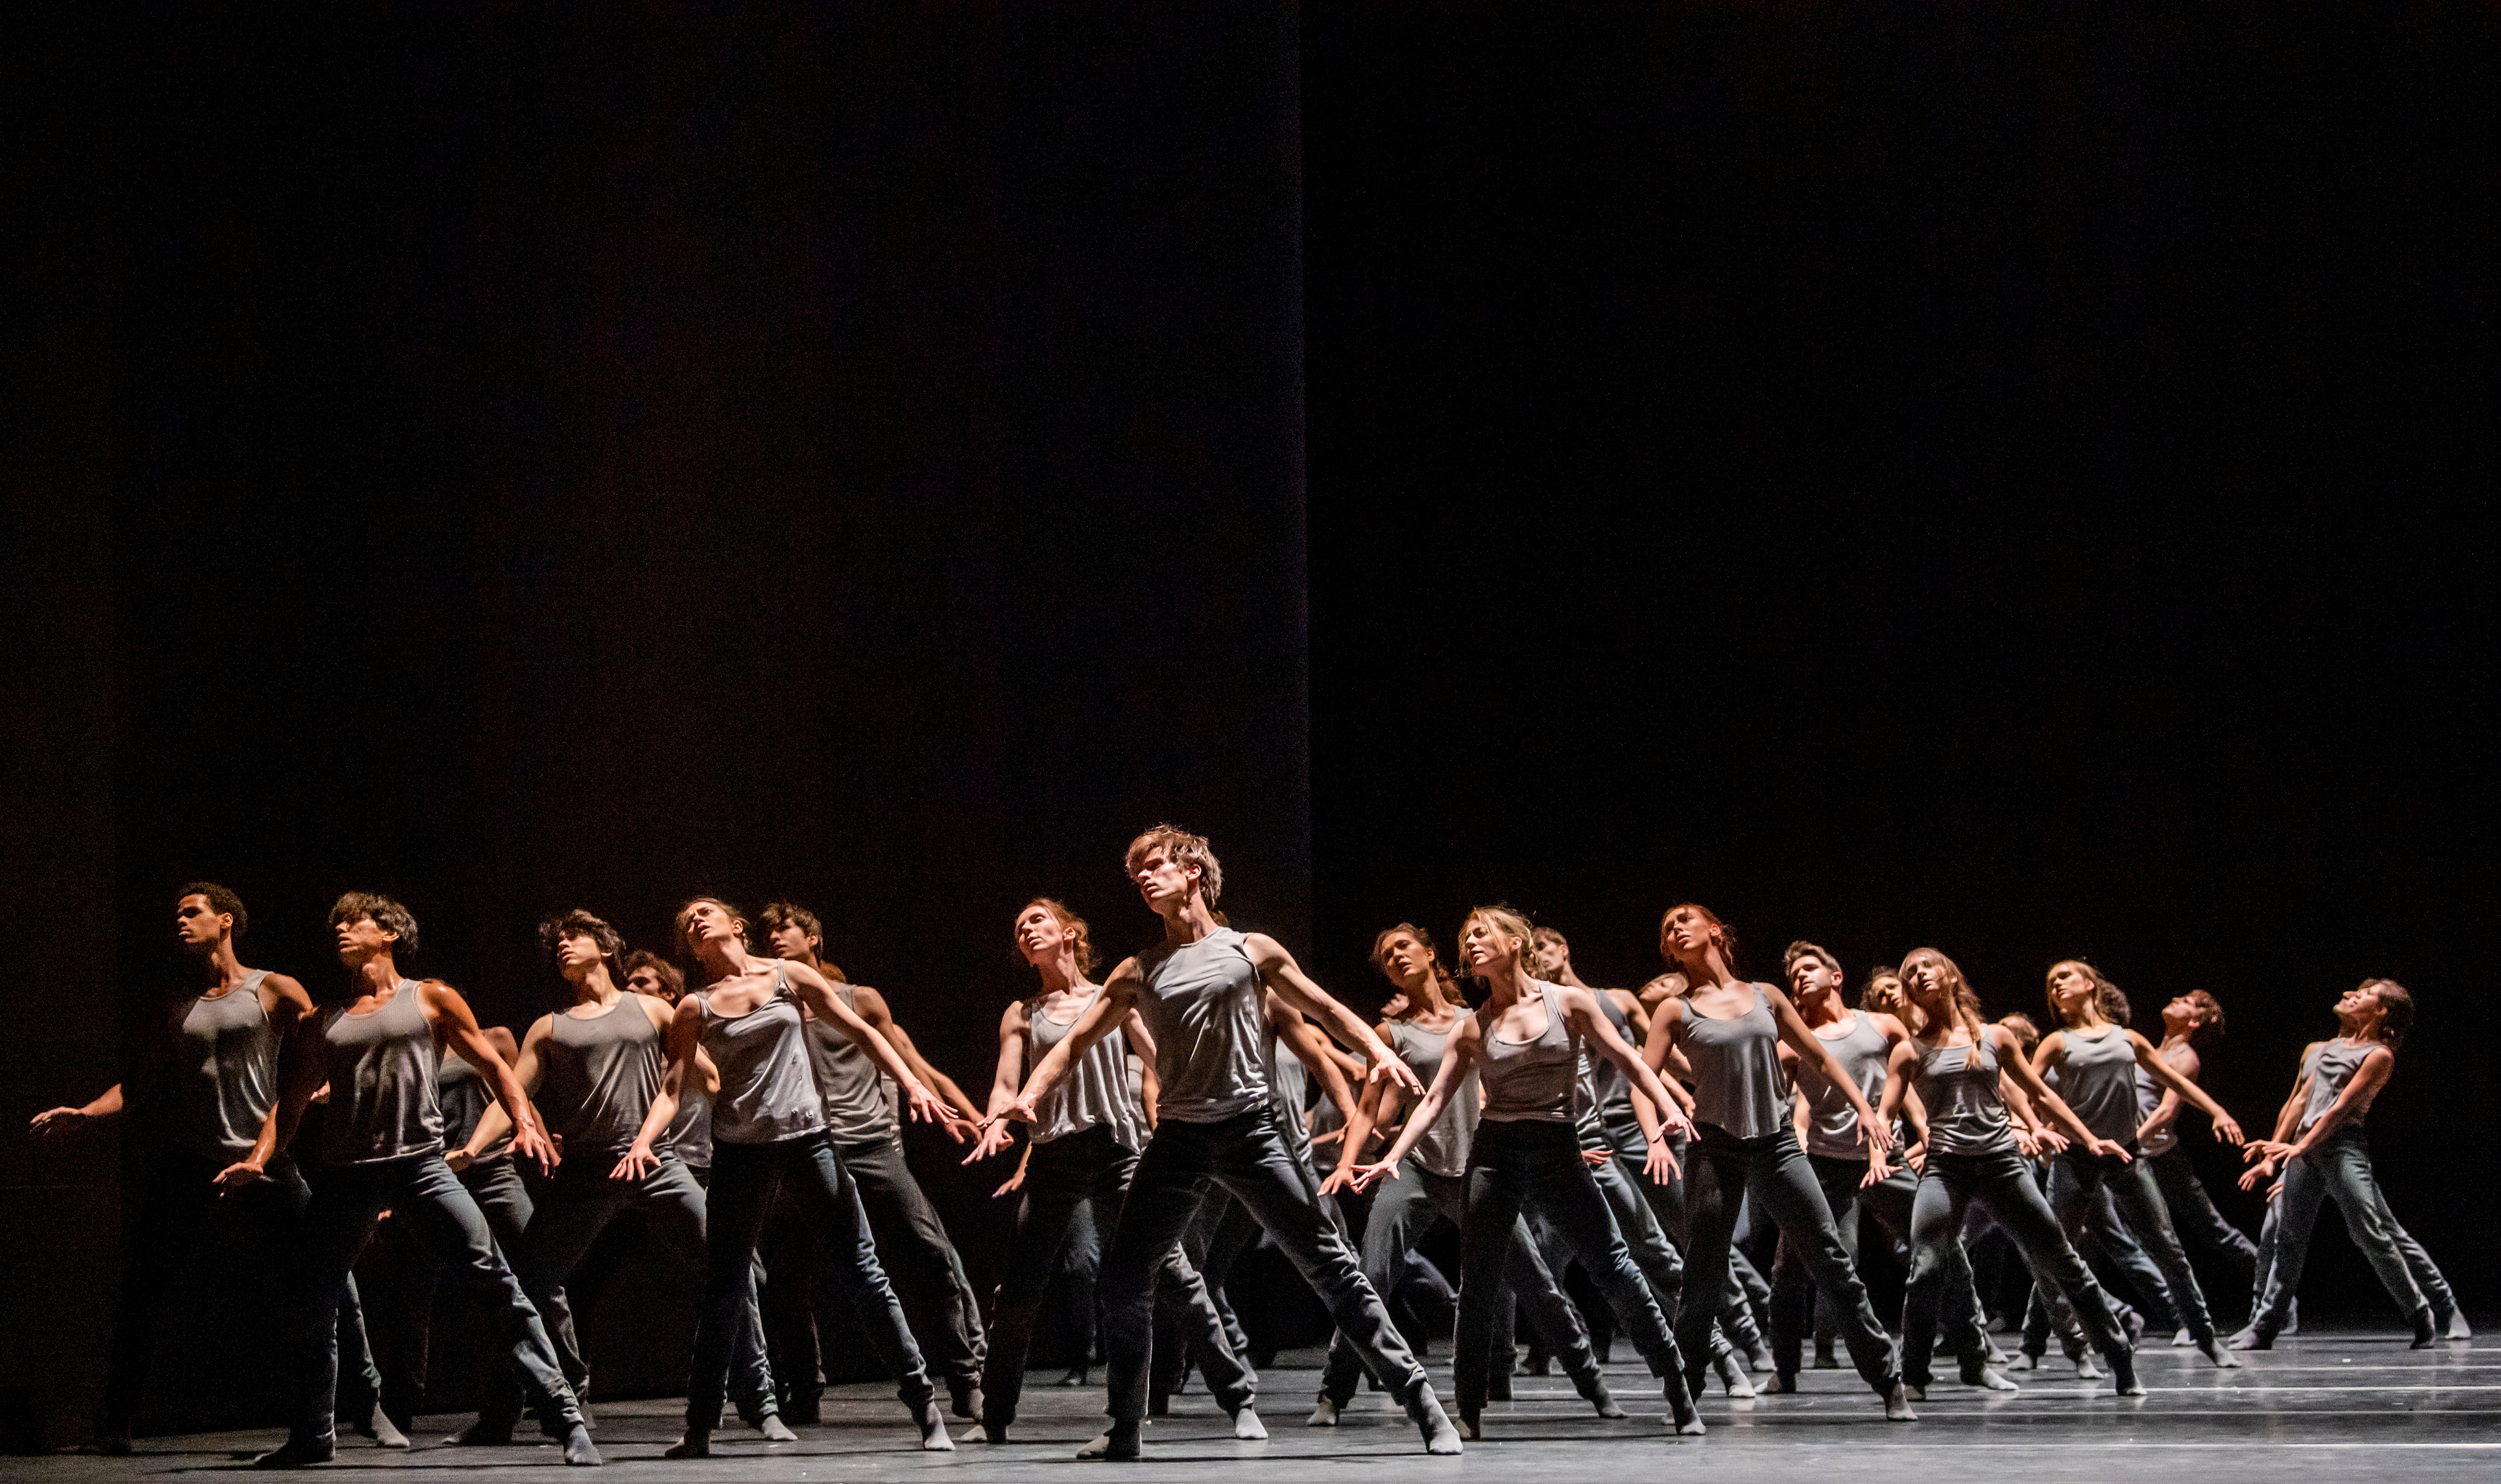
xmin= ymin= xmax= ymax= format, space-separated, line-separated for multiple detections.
xmin=1676 ymin=1124 xmax=1901 ymax=1391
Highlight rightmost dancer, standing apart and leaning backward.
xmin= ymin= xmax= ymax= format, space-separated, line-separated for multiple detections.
xmin=2231 ymin=979 xmax=2458 ymax=1349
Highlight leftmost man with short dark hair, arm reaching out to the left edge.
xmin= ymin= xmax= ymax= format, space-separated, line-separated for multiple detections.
xmin=35 ymin=881 xmax=408 ymax=1456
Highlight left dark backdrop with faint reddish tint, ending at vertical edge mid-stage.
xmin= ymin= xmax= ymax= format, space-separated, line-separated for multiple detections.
xmin=8 ymin=5 xmax=1310 ymax=1424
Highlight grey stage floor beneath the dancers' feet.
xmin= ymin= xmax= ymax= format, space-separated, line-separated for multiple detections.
xmin=15 ymin=1331 xmax=2501 ymax=1484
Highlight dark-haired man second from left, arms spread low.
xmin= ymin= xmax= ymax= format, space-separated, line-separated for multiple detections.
xmin=243 ymin=891 xmax=600 ymax=1469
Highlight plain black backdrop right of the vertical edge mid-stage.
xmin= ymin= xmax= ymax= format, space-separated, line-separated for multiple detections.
xmin=1303 ymin=5 xmax=2501 ymax=1316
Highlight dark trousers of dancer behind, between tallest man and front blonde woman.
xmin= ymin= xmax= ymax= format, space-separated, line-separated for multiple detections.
xmin=1320 ymin=1159 xmax=1601 ymax=1406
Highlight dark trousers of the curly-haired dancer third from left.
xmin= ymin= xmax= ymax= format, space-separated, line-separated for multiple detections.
xmin=513 ymin=1149 xmax=775 ymax=1422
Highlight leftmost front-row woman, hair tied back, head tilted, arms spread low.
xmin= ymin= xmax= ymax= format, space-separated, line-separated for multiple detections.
xmin=660 ymin=896 xmax=960 ymax=1459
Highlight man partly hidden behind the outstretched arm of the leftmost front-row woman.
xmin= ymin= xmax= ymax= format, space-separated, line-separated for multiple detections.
xmin=755 ymin=901 xmax=983 ymax=1422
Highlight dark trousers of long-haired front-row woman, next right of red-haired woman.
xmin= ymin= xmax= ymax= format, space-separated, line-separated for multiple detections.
xmin=1901 ymin=1146 xmax=2128 ymax=1386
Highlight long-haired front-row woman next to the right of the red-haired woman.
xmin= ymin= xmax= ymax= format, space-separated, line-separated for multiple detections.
xmin=1868 ymin=948 xmax=2146 ymax=1396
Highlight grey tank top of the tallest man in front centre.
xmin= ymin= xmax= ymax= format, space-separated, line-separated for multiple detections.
xmin=1138 ymin=928 xmax=1268 ymax=1124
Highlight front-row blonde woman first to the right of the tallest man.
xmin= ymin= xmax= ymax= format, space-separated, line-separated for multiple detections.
xmin=1356 ymin=906 xmax=1703 ymax=1437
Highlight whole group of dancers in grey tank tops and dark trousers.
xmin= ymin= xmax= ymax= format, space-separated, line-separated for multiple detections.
xmin=35 ymin=826 xmax=2466 ymax=1466
